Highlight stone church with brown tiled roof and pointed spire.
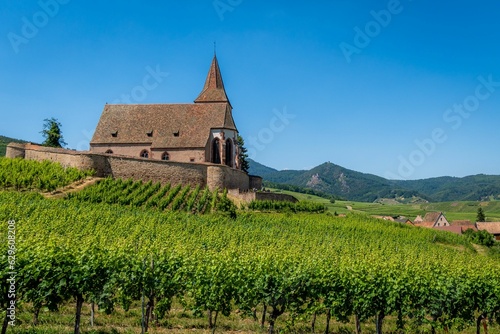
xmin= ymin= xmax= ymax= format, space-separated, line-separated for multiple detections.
xmin=90 ymin=55 xmax=241 ymax=169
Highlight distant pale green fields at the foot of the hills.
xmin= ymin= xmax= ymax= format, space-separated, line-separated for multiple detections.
xmin=272 ymin=189 xmax=500 ymax=222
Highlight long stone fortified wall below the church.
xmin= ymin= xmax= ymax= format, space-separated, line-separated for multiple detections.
xmin=5 ymin=143 xmax=250 ymax=190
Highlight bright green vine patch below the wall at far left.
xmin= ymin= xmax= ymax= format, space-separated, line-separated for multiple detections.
xmin=0 ymin=157 xmax=94 ymax=191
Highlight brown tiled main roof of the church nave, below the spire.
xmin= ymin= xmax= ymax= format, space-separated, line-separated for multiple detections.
xmin=91 ymin=103 xmax=236 ymax=149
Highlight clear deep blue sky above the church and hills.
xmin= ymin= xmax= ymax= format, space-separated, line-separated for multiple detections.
xmin=0 ymin=0 xmax=500 ymax=179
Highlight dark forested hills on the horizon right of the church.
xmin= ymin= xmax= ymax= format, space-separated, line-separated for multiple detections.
xmin=250 ymin=160 xmax=500 ymax=203
